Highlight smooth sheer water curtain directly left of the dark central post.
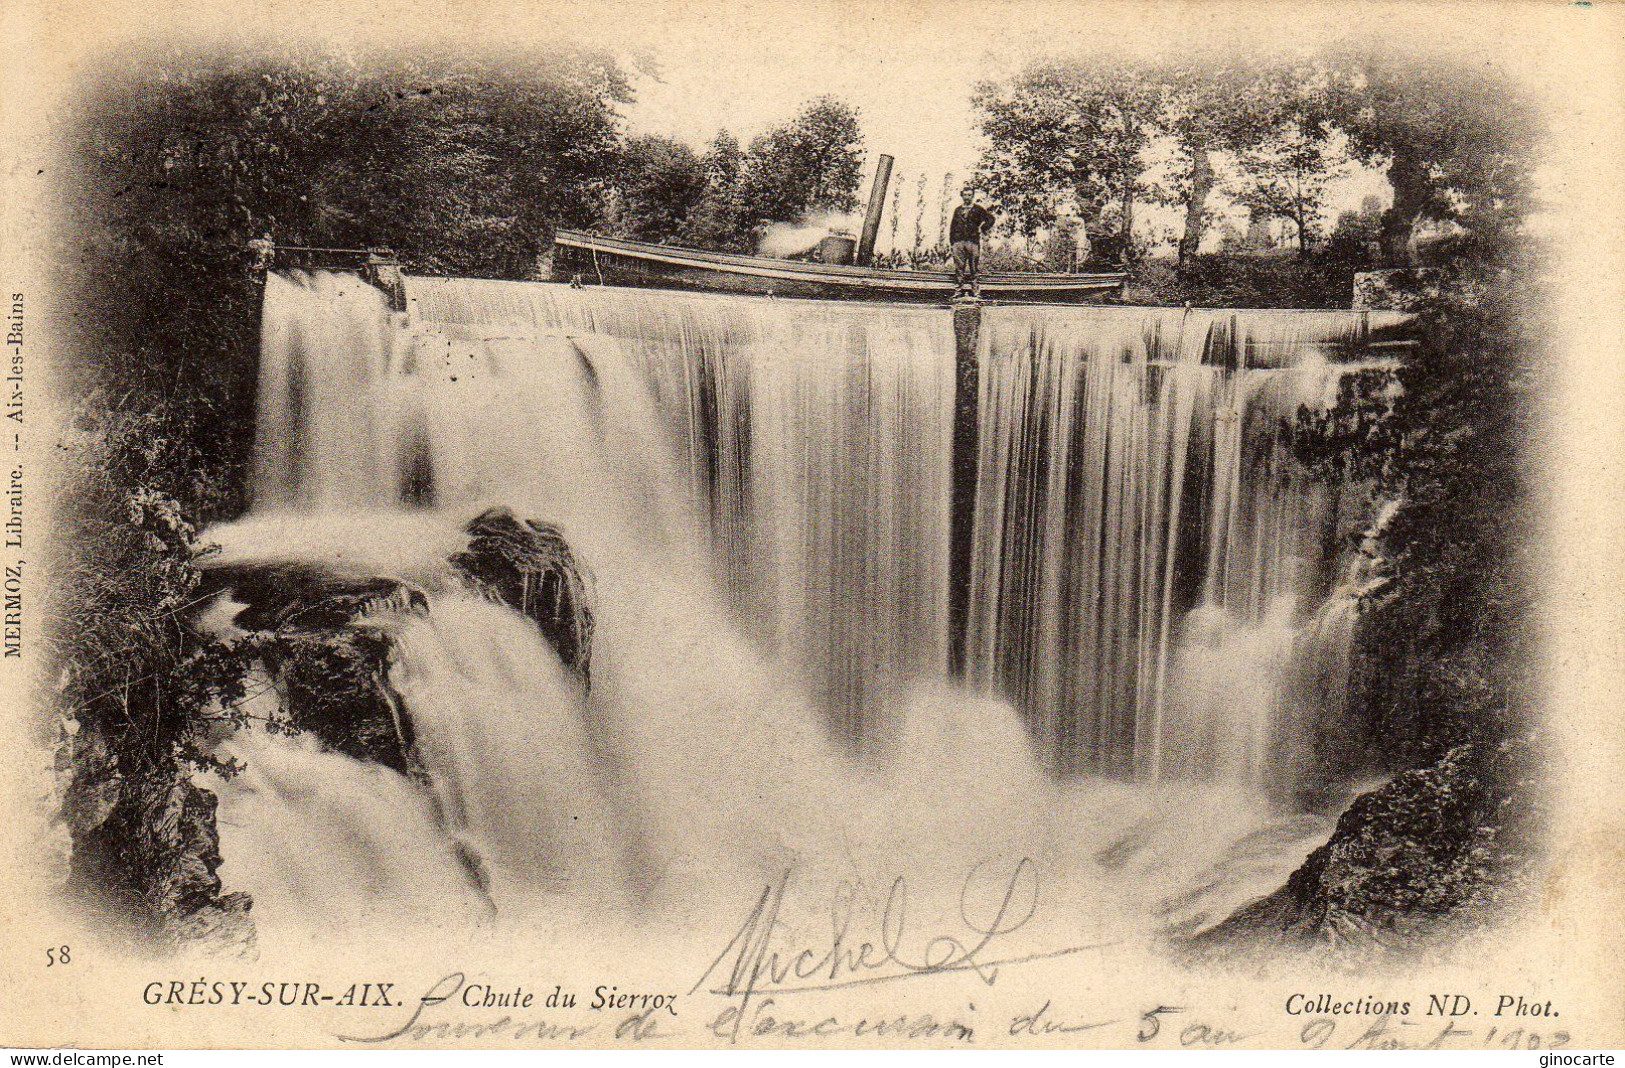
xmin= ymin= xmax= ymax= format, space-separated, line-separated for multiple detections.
xmin=408 ymin=278 xmax=954 ymax=745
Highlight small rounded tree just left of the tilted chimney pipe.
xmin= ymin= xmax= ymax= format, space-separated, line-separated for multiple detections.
xmin=739 ymin=96 xmax=863 ymax=223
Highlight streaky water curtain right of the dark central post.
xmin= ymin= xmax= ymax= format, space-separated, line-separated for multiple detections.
xmin=967 ymin=307 xmax=1360 ymax=785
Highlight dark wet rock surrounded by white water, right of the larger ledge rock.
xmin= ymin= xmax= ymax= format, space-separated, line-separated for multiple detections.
xmin=452 ymin=507 xmax=593 ymax=679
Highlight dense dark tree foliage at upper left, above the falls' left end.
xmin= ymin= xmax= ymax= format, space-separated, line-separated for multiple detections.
xmin=88 ymin=44 xmax=631 ymax=276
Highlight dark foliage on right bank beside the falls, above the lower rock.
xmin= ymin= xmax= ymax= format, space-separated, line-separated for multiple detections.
xmin=1297 ymin=245 xmax=1541 ymax=767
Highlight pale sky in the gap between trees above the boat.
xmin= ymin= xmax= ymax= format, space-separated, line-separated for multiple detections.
xmin=619 ymin=3 xmax=1388 ymax=249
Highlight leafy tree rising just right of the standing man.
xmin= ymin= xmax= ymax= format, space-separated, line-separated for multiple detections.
xmin=972 ymin=59 xmax=1157 ymax=247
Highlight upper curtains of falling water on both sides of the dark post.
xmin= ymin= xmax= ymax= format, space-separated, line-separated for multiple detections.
xmin=240 ymin=275 xmax=1384 ymax=784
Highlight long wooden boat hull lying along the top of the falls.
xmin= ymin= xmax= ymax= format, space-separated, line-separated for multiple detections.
xmin=553 ymin=229 xmax=1123 ymax=304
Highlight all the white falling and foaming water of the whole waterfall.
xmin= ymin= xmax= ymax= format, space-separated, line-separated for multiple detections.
xmin=196 ymin=275 xmax=1378 ymax=933
